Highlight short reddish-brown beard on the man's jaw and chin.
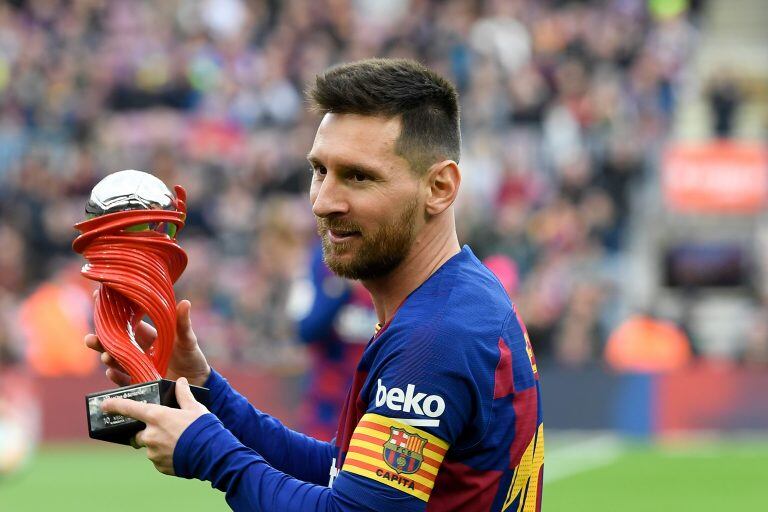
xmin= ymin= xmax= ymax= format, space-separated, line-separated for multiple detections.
xmin=316 ymin=198 xmax=418 ymax=281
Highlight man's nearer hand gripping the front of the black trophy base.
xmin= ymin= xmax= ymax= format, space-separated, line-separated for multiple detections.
xmin=101 ymin=377 xmax=208 ymax=475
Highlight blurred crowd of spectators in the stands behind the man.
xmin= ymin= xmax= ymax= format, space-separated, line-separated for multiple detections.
xmin=0 ymin=0 xmax=696 ymax=370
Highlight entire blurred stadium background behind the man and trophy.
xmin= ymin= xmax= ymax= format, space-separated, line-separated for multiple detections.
xmin=0 ymin=0 xmax=768 ymax=511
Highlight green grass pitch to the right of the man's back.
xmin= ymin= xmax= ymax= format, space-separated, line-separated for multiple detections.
xmin=543 ymin=439 xmax=768 ymax=512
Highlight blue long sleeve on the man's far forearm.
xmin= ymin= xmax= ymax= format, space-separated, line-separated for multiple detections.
xmin=205 ymin=370 xmax=333 ymax=485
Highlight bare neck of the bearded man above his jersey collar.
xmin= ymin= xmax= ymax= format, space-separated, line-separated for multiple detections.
xmin=362 ymin=222 xmax=461 ymax=325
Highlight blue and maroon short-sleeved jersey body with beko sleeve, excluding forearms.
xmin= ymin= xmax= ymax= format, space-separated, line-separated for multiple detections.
xmin=332 ymin=246 xmax=544 ymax=511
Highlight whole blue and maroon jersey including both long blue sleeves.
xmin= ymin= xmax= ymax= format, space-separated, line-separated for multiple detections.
xmin=173 ymin=247 xmax=544 ymax=512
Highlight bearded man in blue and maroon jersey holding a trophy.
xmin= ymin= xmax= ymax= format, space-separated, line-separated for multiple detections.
xmin=86 ymin=59 xmax=543 ymax=511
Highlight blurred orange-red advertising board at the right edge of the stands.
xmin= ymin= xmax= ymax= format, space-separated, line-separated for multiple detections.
xmin=662 ymin=141 xmax=768 ymax=214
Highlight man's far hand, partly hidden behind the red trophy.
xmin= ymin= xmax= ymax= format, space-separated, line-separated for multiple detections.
xmin=85 ymin=300 xmax=211 ymax=386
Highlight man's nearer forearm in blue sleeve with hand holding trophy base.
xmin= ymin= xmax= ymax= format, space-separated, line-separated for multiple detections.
xmin=102 ymin=378 xmax=370 ymax=512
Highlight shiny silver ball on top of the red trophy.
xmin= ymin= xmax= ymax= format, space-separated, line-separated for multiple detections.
xmin=85 ymin=169 xmax=175 ymax=218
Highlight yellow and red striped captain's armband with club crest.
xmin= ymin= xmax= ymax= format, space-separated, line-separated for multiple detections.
xmin=341 ymin=413 xmax=448 ymax=501
